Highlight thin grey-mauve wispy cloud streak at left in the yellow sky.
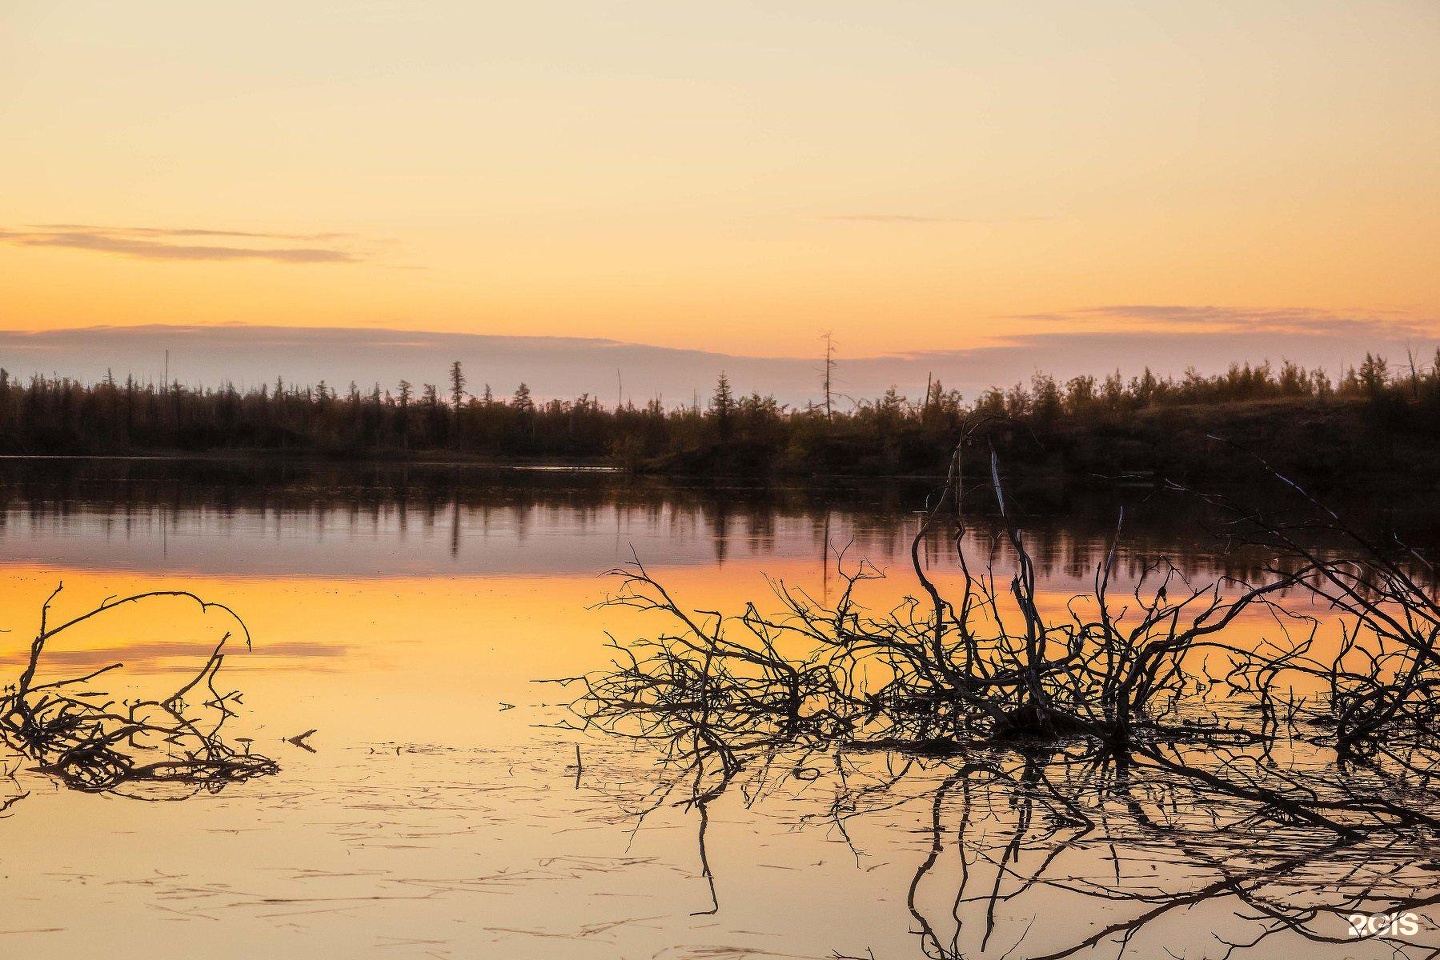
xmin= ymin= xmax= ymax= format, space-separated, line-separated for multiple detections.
xmin=0 ymin=223 xmax=361 ymax=263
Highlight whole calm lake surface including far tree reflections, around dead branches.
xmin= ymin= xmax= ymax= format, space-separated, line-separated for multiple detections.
xmin=0 ymin=462 xmax=1440 ymax=960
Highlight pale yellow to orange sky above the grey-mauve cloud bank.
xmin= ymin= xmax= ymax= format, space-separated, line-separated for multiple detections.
xmin=0 ymin=0 xmax=1440 ymax=356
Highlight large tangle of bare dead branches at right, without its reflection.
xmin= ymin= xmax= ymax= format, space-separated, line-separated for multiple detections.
xmin=562 ymin=450 xmax=1440 ymax=841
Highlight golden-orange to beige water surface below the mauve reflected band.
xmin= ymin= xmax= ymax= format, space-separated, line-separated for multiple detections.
xmin=0 ymin=500 xmax=1384 ymax=960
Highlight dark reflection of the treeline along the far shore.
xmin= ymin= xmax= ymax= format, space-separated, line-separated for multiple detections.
xmin=8 ymin=461 xmax=1428 ymax=580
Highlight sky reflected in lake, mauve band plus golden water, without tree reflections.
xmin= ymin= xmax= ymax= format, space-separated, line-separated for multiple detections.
xmin=0 ymin=477 xmax=1388 ymax=960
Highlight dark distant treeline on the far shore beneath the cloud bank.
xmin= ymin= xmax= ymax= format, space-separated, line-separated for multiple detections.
xmin=0 ymin=353 xmax=1440 ymax=481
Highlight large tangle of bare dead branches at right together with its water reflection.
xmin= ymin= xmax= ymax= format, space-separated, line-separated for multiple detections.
xmin=560 ymin=454 xmax=1440 ymax=957
